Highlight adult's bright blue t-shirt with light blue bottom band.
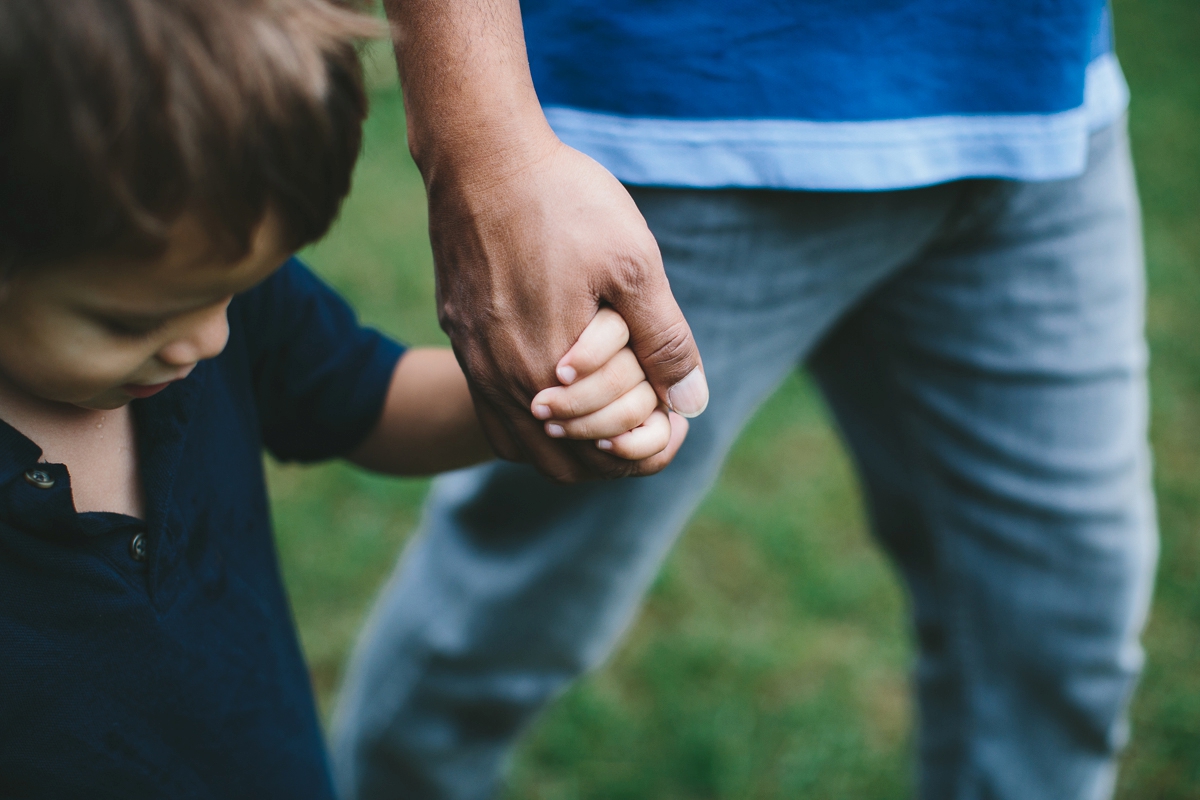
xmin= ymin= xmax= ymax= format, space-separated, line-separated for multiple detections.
xmin=522 ymin=0 xmax=1128 ymax=190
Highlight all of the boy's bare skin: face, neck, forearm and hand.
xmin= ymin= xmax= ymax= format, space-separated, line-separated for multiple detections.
xmin=0 ymin=221 xmax=686 ymax=517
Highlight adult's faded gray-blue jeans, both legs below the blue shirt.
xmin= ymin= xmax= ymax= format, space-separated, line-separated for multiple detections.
xmin=334 ymin=124 xmax=1157 ymax=800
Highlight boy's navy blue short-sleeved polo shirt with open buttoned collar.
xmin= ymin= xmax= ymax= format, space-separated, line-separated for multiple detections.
xmin=0 ymin=259 xmax=403 ymax=800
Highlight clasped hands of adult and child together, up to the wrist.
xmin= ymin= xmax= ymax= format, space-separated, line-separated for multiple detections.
xmin=414 ymin=135 xmax=708 ymax=483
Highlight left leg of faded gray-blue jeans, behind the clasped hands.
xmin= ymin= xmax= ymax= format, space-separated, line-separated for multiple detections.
xmin=332 ymin=187 xmax=956 ymax=800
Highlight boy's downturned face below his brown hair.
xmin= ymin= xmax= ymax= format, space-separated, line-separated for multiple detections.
xmin=0 ymin=223 xmax=288 ymax=409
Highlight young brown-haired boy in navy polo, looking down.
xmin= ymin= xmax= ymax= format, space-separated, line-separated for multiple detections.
xmin=0 ymin=0 xmax=685 ymax=799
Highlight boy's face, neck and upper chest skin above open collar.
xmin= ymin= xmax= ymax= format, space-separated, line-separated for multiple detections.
xmin=0 ymin=224 xmax=286 ymax=517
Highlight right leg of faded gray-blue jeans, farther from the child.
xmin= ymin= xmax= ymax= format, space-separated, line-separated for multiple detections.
xmin=811 ymin=126 xmax=1157 ymax=800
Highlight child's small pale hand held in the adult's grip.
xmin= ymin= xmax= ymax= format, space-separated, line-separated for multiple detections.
xmin=532 ymin=308 xmax=688 ymax=461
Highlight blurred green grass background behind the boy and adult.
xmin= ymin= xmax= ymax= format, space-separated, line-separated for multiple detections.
xmin=283 ymin=0 xmax=1200 ymax=800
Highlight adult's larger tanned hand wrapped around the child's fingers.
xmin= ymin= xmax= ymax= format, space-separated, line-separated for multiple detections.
xmin=428 ymin=137 xmax=708 ymax=482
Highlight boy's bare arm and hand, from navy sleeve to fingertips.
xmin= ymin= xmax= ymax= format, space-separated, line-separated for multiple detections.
xmin=348 ymin=309 xmax=688 ymax=475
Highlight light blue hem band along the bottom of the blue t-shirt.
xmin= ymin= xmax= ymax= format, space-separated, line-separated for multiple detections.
xmin=546 ymin=53 xmax=1129 ymax=191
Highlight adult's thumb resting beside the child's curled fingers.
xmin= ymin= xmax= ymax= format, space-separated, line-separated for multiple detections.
xmin=613 ymin=284 xmax=708 ymax=419
